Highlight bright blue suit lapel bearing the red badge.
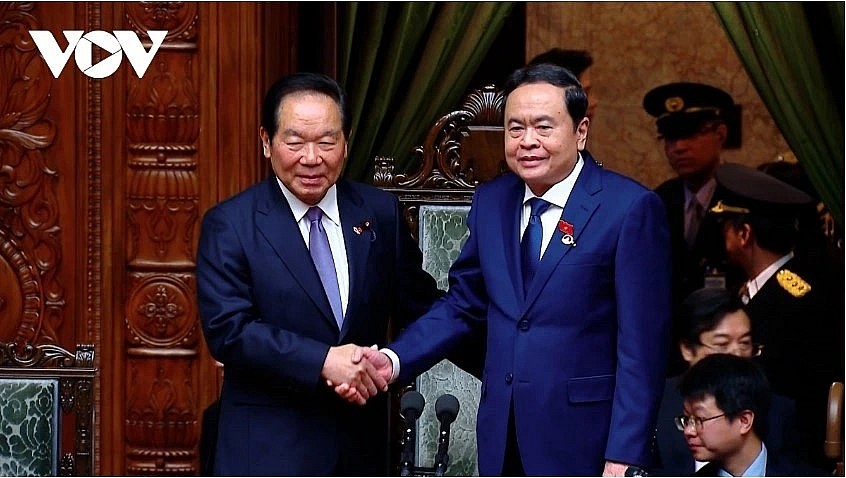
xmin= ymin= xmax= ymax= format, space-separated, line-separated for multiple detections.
xmin=525 ymin=158 xmax=602 ymax=308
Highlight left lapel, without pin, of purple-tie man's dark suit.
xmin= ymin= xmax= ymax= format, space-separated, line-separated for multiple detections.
xmin=256 ymin=175 xmax=338 ymax=329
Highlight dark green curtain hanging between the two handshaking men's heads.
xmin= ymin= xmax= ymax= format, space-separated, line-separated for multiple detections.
xmin=338 ymin=2 xmax=513 ymax=181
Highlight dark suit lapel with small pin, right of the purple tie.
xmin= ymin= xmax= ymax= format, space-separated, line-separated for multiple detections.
xmin=338 ymin=181 xmax=376 ymax=337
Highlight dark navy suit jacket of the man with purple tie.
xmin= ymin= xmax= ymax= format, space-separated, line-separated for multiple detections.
xmin=197 ymin=176 xmax=441 ymax=476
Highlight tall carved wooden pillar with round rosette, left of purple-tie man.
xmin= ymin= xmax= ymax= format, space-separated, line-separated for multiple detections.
xmin=125 ymin=2 xmax=200 ymax=475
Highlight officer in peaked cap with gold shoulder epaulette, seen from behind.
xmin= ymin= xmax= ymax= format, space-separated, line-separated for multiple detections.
xmin=710 ymin=163 xmax=843 ymax=467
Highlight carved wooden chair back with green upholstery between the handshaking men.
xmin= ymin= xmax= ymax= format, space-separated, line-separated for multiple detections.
xmin=374 ymin=85 xmax=505 ymax=476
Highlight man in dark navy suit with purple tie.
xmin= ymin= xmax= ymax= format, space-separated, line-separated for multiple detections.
xmin=196 ymin=74 xmax=440 ymax=476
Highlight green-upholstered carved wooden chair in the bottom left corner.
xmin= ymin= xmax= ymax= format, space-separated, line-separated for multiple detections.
xmin=0 ymin=342 xmax=97 ymax=476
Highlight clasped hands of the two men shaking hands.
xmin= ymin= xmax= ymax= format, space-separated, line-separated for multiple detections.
xmin=320 ymin=344 xmax=394 ymax=405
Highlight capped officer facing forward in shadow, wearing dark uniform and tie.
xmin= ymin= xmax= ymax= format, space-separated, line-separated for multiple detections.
xmin=643 ymin=82 xmax=742 ymax=375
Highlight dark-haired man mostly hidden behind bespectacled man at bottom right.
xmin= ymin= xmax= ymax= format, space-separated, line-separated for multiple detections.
xmin=651 ymin=288 xmax=798 ymax=476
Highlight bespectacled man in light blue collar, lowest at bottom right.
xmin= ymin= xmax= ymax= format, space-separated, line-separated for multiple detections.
xmin=675 ymin=354 xmax=823 ymax=476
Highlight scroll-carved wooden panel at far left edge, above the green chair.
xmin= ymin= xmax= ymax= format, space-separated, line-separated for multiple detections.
xmin=0 ymin=3 xmax=65 ymax=343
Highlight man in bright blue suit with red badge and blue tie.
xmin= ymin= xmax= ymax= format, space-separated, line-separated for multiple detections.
xmin=342 ymin=64 xmax=670 ymax=476
